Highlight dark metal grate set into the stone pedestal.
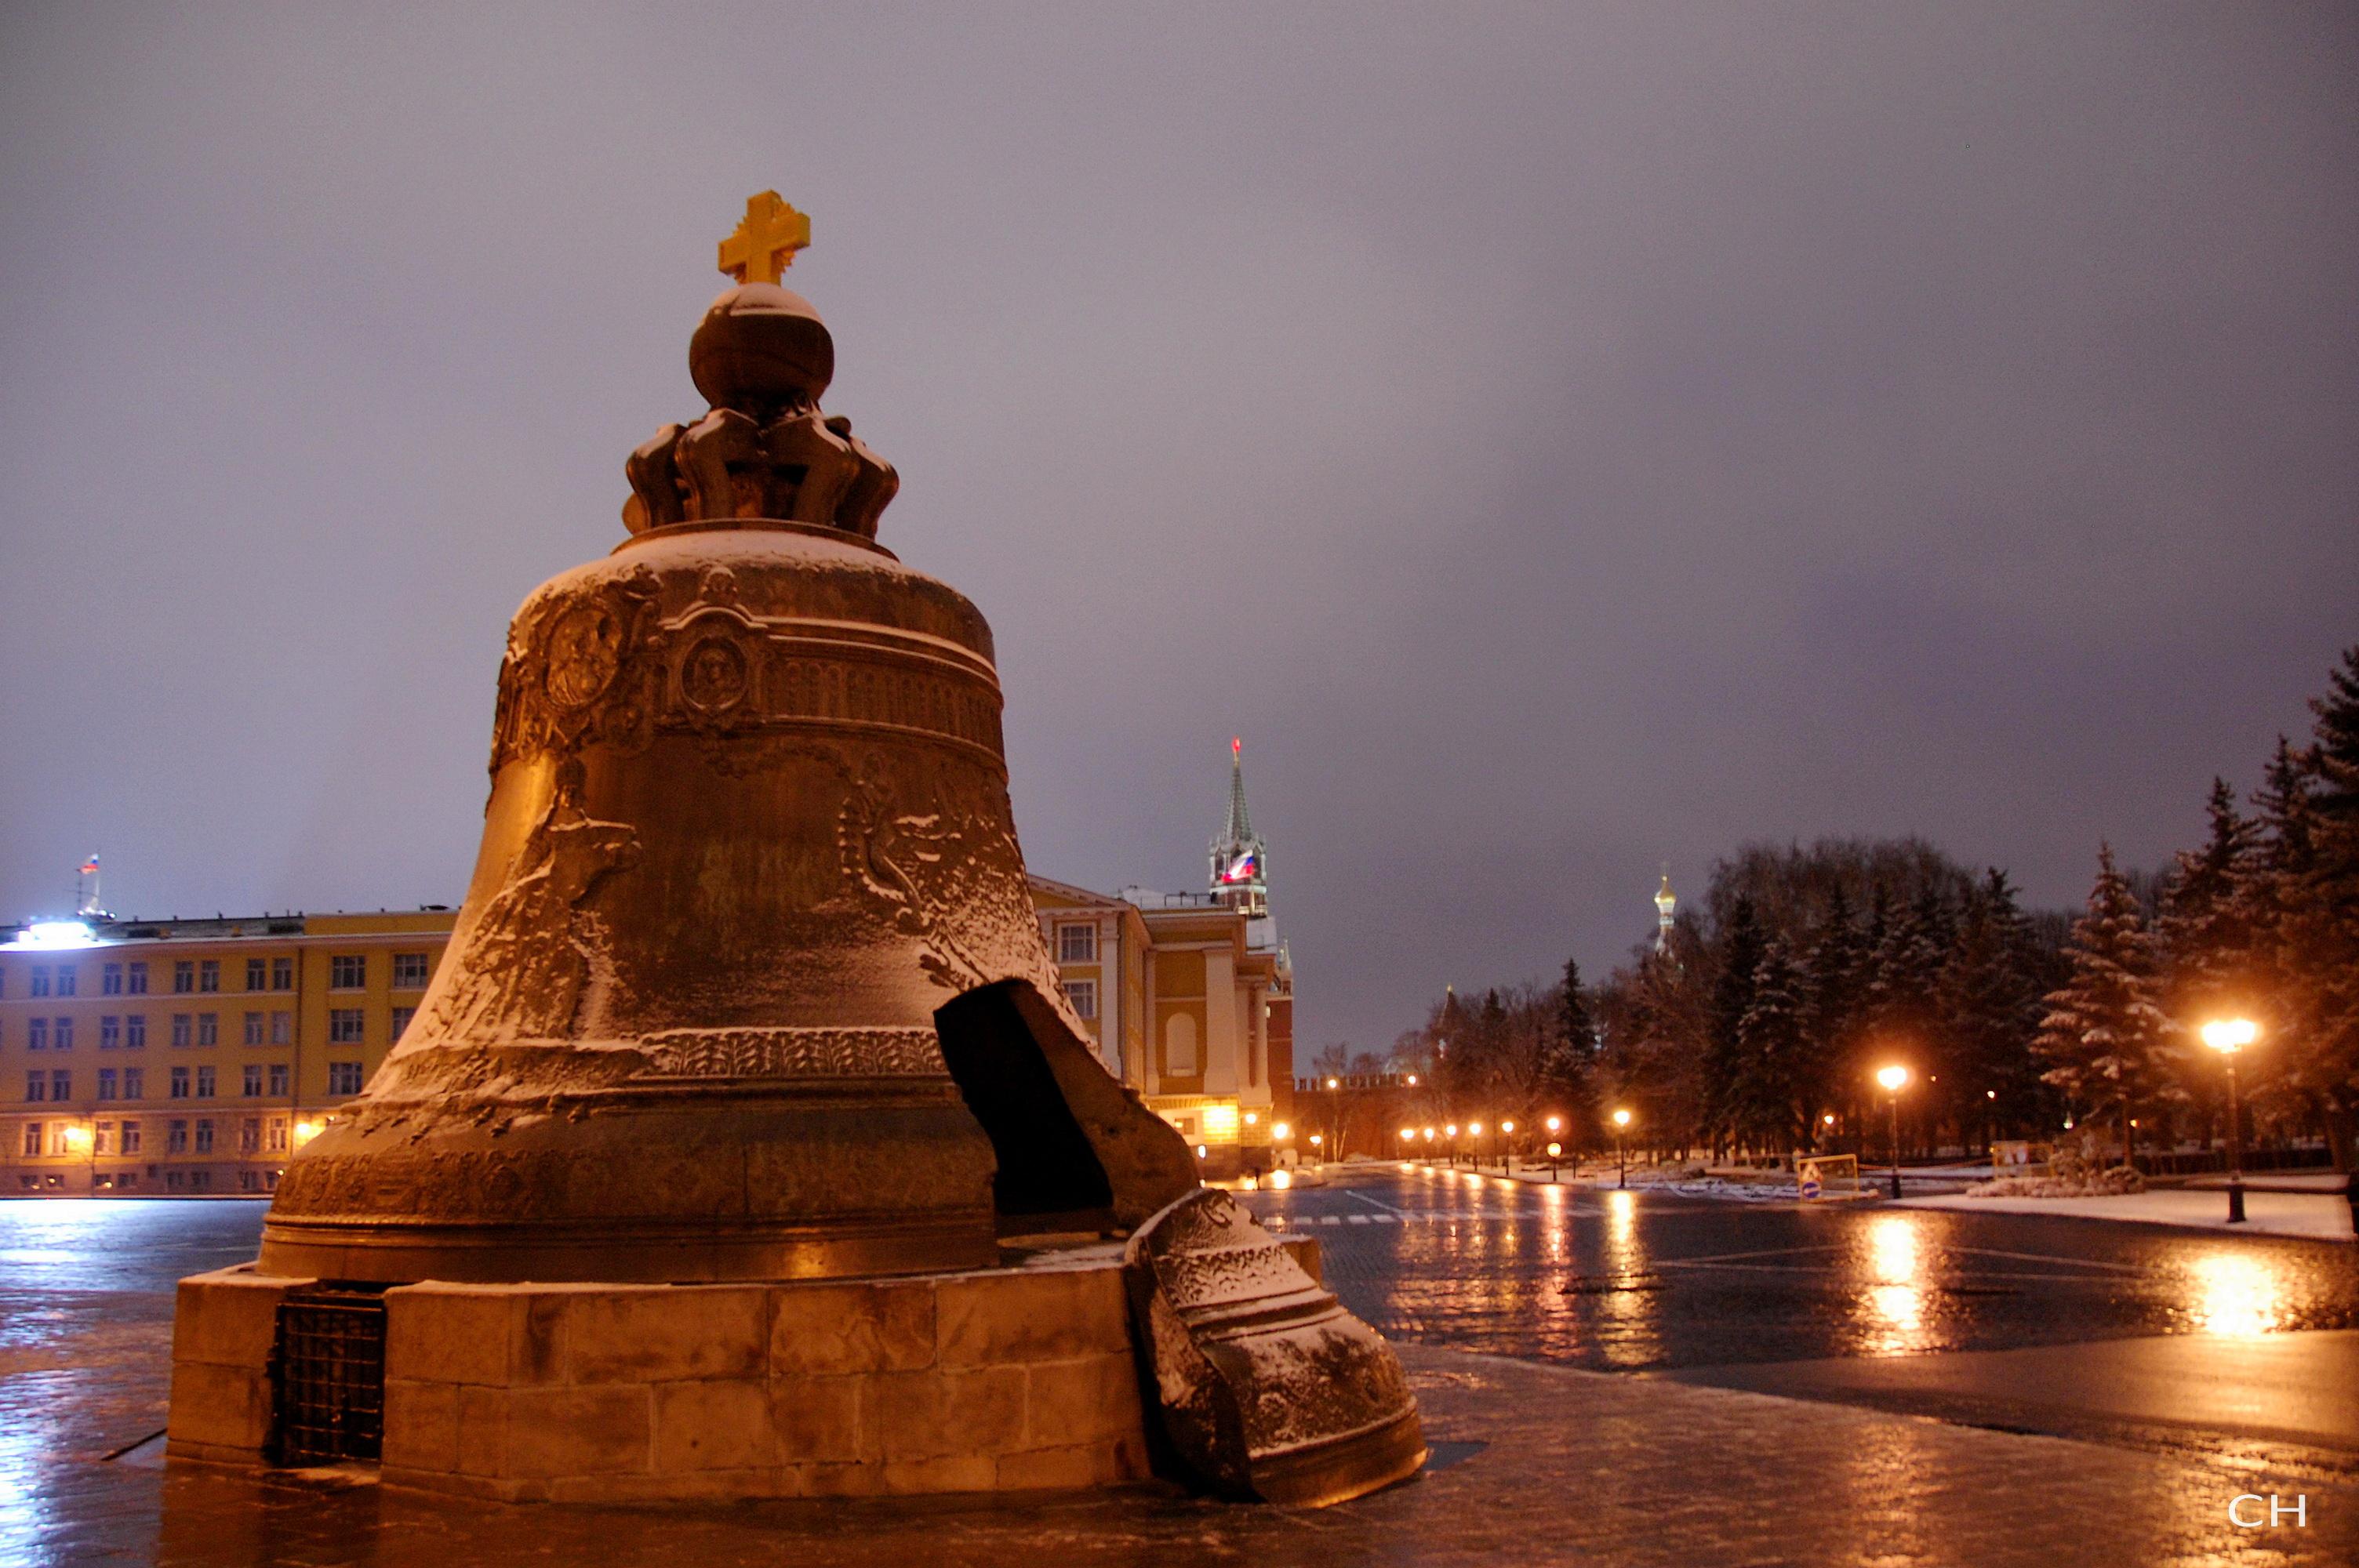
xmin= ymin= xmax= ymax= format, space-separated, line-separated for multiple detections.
xmin=271 ymin=1287 xmax=384 ymax=1467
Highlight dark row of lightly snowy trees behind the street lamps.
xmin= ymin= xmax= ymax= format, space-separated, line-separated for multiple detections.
xmin=1354 ymin=648 xmax=2359 ymax=1167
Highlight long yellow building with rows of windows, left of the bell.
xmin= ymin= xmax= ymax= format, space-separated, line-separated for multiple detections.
xmin=0 ymin=908 xmax=456 ymax=1196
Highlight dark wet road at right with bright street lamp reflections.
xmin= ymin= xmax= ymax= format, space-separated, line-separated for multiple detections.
xmin=1245 ymin=1165 xmax=2359 ymax=1367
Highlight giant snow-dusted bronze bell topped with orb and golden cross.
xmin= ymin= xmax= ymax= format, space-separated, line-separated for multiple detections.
xmin=262 ymin=191 xmax=1196 ymax=1280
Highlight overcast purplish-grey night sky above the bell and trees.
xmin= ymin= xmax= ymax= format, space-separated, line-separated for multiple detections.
xmin=0 ymin=2 xmax=2359 ymax=1051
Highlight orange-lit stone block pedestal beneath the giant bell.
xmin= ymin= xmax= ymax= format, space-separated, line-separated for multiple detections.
xmin=170 ymin=1247 xmax=1255 ymax=1500
